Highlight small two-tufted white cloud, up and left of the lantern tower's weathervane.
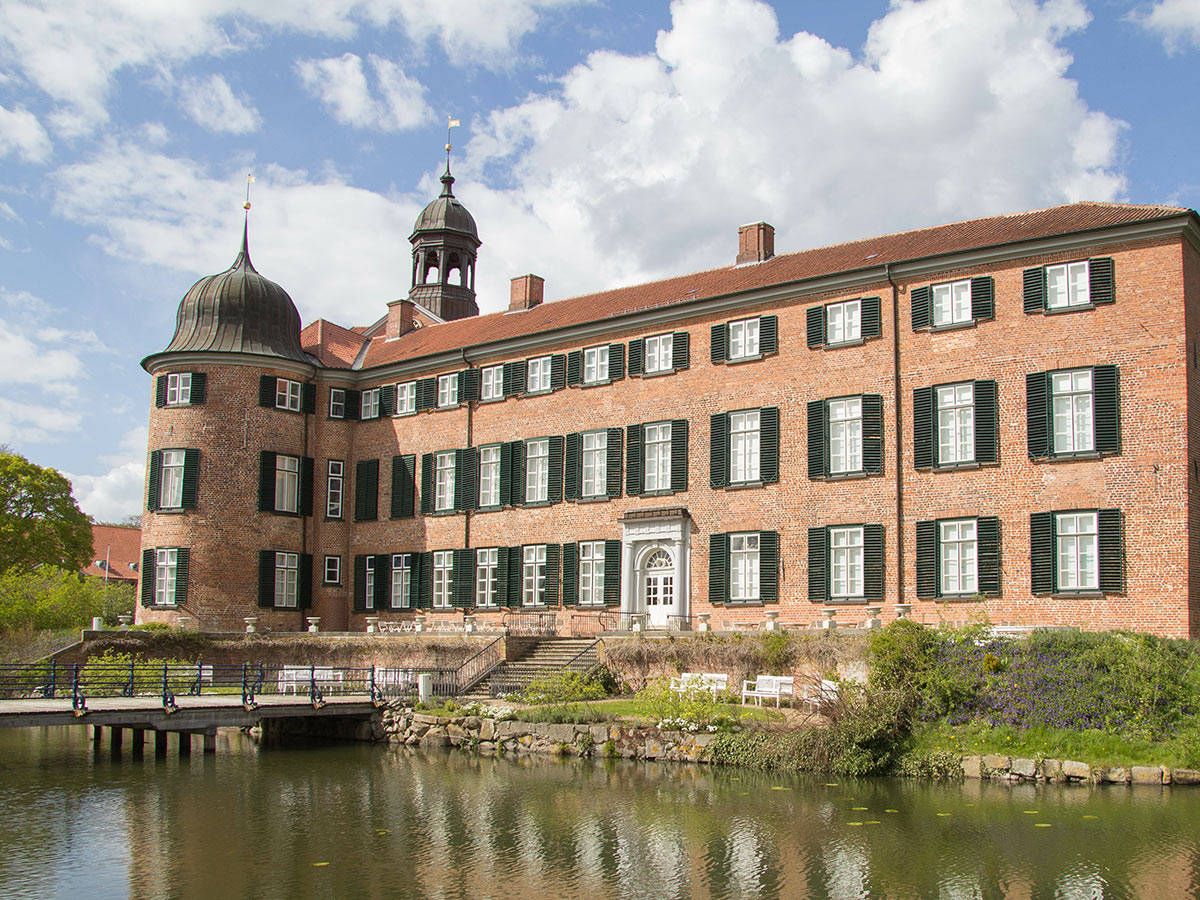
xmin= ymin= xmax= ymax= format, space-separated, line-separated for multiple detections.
xmin=296 ymin=53 xmax=433 ymax=131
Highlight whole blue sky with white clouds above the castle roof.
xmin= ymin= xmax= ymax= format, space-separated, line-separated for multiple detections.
xmin=0 ymin=0 xmax=1200 ymax=520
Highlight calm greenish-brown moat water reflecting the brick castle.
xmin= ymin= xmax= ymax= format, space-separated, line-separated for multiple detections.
xmin=0 ymin=727 xmax=1200 ymax=900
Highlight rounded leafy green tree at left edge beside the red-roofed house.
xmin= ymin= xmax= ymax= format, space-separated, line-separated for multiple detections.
xmin=0 ymin=452 xmax=91 ymax=572
